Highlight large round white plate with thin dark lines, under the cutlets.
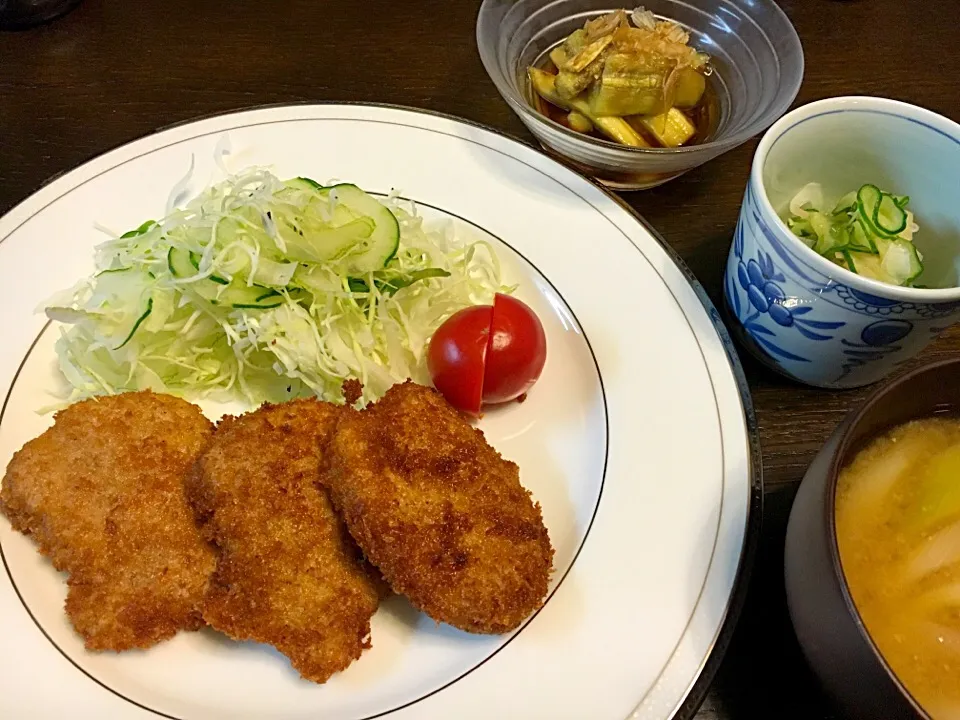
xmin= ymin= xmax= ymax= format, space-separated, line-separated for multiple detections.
xmin=0 ymin=105 xmax=759 ymax=720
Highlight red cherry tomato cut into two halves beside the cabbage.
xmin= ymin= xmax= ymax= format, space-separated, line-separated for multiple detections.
xmin=427 ymin=293 xmax=547 ymax=415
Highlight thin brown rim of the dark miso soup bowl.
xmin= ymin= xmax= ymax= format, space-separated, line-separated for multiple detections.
xmin=824 ymin=357 xmax=960 ymax=720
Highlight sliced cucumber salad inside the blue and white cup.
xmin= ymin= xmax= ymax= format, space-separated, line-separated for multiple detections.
xmin=786 ymin=183 xmax=923 ymax=286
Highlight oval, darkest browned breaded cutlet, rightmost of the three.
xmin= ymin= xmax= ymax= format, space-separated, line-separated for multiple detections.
xmin=321 ymin=382 xmax=553 ymax=633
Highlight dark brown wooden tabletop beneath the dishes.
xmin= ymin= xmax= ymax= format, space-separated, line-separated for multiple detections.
xmin=0 ymin=0 xmax=960 ymax=720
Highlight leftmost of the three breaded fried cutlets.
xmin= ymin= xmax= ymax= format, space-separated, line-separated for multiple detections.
xmin=0 ymin=392 xmax=214 ymax=651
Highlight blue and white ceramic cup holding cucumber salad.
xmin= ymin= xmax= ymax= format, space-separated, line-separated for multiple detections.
xmin=724 ymin=97 xmax=960 ymax=388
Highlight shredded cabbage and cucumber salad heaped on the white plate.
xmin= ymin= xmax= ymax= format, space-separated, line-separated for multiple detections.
xmin=45 ymin=168 xmax=509 ymax=404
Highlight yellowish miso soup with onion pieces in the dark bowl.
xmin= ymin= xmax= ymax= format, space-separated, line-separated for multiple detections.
xmin=836 ymin=418 xmax=960 ymax=720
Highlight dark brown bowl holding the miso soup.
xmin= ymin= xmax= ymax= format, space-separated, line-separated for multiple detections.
xmin=784 ymin=358 xmax=960 ymax=720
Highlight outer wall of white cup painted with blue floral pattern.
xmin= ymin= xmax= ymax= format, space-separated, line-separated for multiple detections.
xmin=724 ymin=182 xmax=960 ymax=388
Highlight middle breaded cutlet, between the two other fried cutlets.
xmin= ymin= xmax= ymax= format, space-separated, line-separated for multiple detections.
xmin=188 ymin=399 xmax=380 ymax=683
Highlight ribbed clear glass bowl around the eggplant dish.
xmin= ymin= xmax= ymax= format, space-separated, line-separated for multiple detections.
xmin=477 ymin=0 xmax=803 ymax=190
